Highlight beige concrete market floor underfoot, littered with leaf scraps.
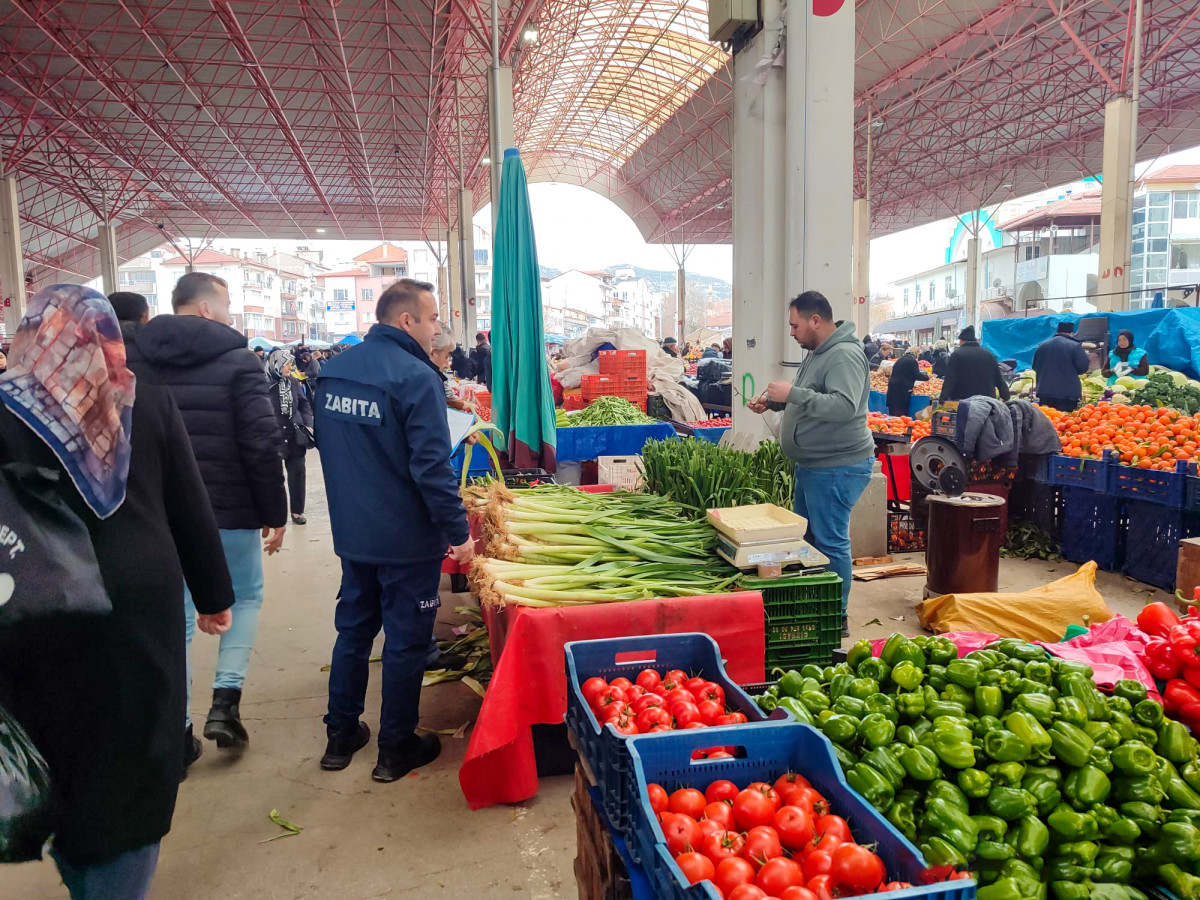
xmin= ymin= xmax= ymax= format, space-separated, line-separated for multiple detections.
xmin=0 ymin=468 xmax=1166 ymax=900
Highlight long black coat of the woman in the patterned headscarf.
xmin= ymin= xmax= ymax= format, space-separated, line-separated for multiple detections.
xmin=0 ymin=382 xmax=233 ymax=865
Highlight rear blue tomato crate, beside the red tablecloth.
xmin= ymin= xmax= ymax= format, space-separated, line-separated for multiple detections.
xmin=563 ymin=634 xmax=792 ymax=849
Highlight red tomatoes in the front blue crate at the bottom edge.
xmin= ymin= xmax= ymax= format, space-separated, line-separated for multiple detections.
xmin=647 ymin=773 xmax=945 ymax=900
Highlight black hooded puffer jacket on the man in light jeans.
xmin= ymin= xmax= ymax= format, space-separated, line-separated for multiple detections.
xmin=126 ymin=316 xmax=288 ymax=529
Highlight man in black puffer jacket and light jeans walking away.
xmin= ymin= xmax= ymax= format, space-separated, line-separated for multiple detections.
xmin=126 ymin=272 xmax=288 ymax=761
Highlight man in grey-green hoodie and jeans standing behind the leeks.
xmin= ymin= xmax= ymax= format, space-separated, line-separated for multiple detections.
xmin=746 ymin=290 xmax=875 ymax=636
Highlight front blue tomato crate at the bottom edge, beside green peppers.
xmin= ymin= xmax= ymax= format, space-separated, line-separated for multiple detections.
xmin=630 ymin=722 xmax=976 ymax=900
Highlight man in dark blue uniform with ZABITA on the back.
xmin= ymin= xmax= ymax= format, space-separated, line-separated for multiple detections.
xmin=313 ymin=278 xmax=474 ymax=781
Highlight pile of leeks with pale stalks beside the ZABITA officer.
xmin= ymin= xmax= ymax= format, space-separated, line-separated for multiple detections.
xmin=467 ymin=484 xmax=740 ymax=606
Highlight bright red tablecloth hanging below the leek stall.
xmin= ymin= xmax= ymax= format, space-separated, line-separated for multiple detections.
xmin=458 ymin=593 xmax=766 ymax=809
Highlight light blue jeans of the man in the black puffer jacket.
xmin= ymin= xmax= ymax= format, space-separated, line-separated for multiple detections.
xmin=184 ymin=528 xmax=263 ymax=725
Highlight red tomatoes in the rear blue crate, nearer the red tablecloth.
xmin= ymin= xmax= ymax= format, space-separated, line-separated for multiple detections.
xmin=580 ymin=668 xmax=746 ymax=734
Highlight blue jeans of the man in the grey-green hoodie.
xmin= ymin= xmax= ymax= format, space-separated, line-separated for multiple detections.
xmin=793 ymin=457 xmax=875 ymax=616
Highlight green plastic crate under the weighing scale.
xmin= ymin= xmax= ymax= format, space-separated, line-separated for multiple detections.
xmin=743 ymin=572 xmax=841 ymax=671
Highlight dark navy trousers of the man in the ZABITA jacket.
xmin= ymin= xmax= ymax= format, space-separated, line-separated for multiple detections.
xmin=325 ymin=559 xmax=442 ymax=746
